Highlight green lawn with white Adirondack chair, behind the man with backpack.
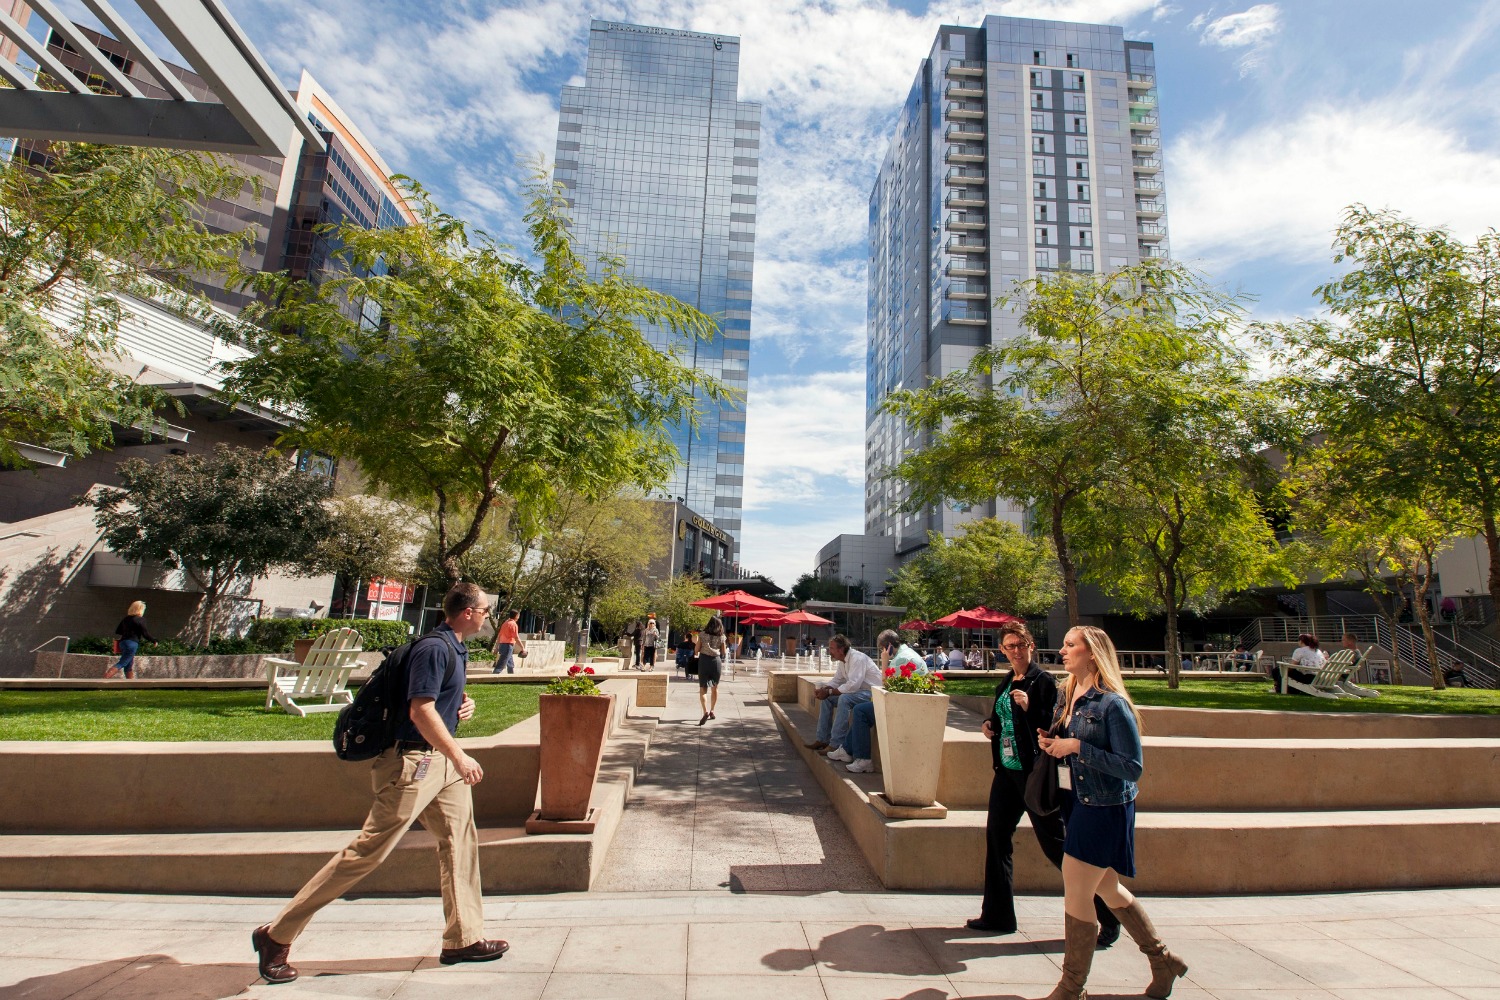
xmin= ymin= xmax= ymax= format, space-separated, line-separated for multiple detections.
xmin=0 ymin=684 xmax=543 ymax=742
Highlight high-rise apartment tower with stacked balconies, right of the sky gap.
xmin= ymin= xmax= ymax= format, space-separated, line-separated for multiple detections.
xmin=864 ymin=16 xmax=1167 ymax=556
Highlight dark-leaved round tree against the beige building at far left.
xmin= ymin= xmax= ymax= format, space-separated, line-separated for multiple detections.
xmin=80 ymin=445 xmax=329 ymax=645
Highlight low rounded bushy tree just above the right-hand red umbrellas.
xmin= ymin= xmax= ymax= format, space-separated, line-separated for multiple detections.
xmin=890 ymin=517 xmax=1062 ymax=619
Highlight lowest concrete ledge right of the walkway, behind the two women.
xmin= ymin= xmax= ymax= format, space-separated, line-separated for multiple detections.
xmin=771 ymin=705 xmax=1500 ymax=894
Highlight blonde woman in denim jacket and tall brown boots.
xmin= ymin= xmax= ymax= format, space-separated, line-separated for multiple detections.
xmin=1037 ymin=625 xmax=1188 ymax=1000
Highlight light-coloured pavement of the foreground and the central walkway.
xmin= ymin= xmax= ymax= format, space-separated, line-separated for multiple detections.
xmin=0 ymin=668 xmax=1500 ymax=1000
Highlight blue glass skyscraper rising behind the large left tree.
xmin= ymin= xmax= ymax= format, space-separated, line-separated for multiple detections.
xmin=554 ymin=21 xmax=761 ymax=546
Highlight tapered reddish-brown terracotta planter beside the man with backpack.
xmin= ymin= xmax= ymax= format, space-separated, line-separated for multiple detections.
xmin=537 ymin=694 xmax=615 ymax=822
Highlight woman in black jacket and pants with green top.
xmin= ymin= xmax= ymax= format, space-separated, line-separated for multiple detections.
xmin=966 ymin=622 xmax=1121 ymax=948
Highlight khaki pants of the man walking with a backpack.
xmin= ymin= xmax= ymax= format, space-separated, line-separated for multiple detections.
xmin=270 ymin=750 xmax=485 ymax=948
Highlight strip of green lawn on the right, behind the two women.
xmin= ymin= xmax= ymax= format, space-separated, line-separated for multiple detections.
xmin=944 ymin=678 xmax=1500 ymax=715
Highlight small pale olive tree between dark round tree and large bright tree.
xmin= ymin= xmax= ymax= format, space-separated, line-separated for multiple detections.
xmin=309 ymin=496 xmax=420 ymax=610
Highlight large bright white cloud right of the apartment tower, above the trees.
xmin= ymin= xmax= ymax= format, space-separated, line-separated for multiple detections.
xmin=1167 ymin=99 xmax=1500 ymax=271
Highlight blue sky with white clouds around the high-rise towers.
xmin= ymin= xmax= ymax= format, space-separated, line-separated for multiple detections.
xmin=52 ymin=0 xmax=1500 ymax=586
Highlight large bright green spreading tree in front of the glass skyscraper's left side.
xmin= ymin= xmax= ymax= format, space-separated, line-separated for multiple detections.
xmin=230 ymin=180 xmax=728 ymax=580
